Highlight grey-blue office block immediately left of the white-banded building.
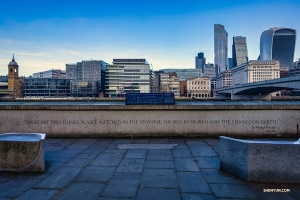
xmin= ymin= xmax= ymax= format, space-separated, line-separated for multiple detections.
xmin=66 ymin=60 xmax=107 ymax=97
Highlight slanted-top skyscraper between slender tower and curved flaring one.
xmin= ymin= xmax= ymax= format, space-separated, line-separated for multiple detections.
xmin=232 ymin=36 xmax=248 ymax=67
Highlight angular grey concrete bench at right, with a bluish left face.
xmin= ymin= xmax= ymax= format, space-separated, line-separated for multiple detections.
xmin=220 ymin=136 xmax=300 ymax=183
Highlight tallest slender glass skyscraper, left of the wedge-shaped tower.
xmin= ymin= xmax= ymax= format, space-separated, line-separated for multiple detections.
xmin=214 ymin=24 xmax=228 ymax=74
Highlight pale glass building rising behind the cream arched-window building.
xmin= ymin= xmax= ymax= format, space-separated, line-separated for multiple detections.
xmin=160 ymin=69 xmax=202 ymax=81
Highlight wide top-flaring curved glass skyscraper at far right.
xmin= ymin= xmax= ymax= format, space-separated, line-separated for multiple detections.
xmin=259 ymin=28 xmax=296 ymax=70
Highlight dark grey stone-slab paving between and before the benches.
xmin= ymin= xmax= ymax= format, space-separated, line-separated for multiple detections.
xmin=0 ymin=138 xmax=300 ymax=200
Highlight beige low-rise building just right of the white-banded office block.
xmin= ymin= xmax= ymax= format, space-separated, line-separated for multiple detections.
xmin=160 ymin=72 xmax=180 ymax=97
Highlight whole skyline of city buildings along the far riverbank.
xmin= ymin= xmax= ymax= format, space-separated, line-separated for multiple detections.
xmin=0 ymin=24 xmax=300 ymax=98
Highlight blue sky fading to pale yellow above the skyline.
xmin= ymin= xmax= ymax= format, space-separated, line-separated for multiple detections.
xmin=0 ymin=0 xmax=300 ymax=76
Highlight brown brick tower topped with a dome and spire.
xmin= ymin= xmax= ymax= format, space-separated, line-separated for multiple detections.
xmin=8 ymin=55 xmax=24 ymax=98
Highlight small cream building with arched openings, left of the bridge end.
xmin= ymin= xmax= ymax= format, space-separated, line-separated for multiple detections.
xmin=186 ymin=77 xmax=211 ymax=98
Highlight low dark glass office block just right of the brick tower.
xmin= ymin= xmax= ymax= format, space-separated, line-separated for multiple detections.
xmin=24 ymin=78 xmax=71 ymax=98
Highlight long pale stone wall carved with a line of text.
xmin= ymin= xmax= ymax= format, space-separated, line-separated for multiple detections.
xmin=0 ymin=104 xmax=300 ymax=137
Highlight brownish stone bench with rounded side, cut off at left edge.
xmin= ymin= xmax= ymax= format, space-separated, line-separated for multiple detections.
xmin=0 ymin=133 xmax=46 ymax=172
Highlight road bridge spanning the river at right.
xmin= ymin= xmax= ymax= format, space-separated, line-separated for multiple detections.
xmin=216 ymin=76 xmax=300 ymax=100
